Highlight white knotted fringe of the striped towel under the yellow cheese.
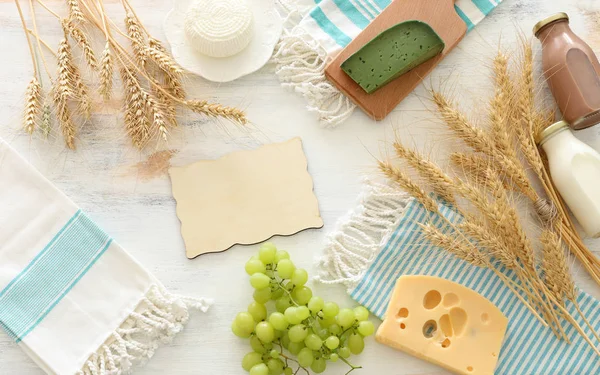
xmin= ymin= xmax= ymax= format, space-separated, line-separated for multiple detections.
xmin=316 ymin=178 xmax=413 ymax=290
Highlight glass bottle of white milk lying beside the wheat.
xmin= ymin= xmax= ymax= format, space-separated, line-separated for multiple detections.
xmin=538 ymin=121 xmax=600 ymax=237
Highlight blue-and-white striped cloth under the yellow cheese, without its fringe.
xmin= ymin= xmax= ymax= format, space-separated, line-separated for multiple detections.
xmin=350 ymin=200 xmax=600 ymax=375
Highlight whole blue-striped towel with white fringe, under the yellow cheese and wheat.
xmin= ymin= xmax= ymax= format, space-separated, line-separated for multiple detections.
xmin=319 ymin=181 xmax=600 ymax=375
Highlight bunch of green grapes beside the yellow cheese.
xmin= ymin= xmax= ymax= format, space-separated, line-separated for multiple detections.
xmin=231 ymin=243 xmax=375 ymax=375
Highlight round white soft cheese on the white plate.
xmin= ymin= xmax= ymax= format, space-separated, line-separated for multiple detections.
xmin=185 ymin=0 xmax=253 ymax=57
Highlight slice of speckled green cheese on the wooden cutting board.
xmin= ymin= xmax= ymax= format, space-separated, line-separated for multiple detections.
xmin=341 ymin=20 xmax=445 ymax=94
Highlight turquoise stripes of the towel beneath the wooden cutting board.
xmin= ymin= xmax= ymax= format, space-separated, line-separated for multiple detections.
xmin=310 ymin=0 xmax=501 ymax=47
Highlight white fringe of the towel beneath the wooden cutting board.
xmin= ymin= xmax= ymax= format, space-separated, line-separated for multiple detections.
xmin=271 ymin=0 xmax=356 ymax=127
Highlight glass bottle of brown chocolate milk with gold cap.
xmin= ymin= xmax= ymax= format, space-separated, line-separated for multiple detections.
xmin=533 ymin=13 xmax=600 ymax=129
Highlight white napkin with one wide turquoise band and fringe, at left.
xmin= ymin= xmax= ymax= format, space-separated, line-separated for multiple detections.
xmin=0 ymin=139 xmax=210 ymax=375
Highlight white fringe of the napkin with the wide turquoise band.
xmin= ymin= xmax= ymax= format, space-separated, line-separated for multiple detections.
xmin=77 ymin=285 xmax=212 ymax=375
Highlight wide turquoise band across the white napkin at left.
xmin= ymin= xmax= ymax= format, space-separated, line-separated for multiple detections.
xmin=0 ymin=210 xmax=112 ymax=342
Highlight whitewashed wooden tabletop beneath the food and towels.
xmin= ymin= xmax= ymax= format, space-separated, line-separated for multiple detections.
xmin=0 ymin=0 xmax=600 ymax=375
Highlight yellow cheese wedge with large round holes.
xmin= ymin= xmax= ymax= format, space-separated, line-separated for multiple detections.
xmin=376 ymin=276 xmax=508 ymax=375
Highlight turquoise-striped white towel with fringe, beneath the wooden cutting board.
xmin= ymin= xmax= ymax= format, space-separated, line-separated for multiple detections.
xmin=273 ymin=0 xmax=502 ymax=126
